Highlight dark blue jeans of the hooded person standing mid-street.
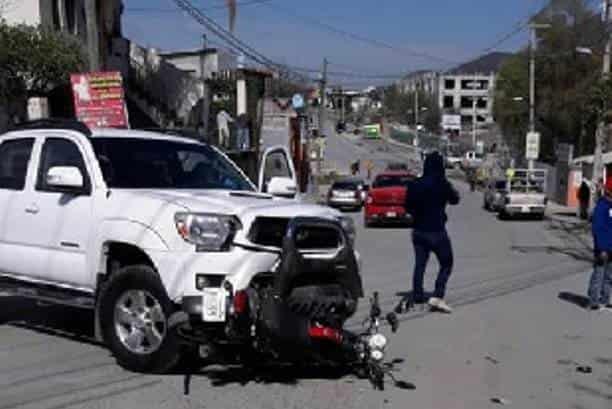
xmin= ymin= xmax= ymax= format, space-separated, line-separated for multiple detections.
xmin=412 ymin=230 xmax=453 ymax=303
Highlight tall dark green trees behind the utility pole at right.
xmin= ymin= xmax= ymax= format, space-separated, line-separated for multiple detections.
xmin=494 ymin=0 xmax=612 ymax=162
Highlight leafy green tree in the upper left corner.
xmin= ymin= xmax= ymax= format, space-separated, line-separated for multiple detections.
xmin=0 ymin=21 xmax=86 ymax=121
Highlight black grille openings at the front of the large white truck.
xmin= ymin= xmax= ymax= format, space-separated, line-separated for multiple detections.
xmin=248 ymin=217 xmax=342 ymax=250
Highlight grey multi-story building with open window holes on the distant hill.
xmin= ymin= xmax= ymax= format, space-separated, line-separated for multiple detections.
xmin=438 ymin=73 xmax=495 ymax=125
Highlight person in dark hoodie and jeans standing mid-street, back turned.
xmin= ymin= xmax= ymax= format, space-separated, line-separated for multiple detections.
xmin=406 ymin=152 xmax=459 ymax=313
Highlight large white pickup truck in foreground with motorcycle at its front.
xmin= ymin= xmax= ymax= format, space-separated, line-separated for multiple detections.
xmin=0 ymin=121 xmax=354 ymax=372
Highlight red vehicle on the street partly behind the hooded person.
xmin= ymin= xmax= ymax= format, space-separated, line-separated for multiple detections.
xmin=364 ymin=171 xmax=416 ymax=227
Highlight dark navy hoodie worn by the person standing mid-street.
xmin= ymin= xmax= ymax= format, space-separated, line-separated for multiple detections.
xmin=406 ymin=152 xmax=459 ymax=232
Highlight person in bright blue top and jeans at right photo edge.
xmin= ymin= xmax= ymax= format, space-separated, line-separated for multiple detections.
xmin=589 ymin=179 xmax=612 ymax=310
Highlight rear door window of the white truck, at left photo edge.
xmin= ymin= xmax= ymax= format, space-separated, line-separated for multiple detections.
xmin=0 ymin=138 xmax=34 ymax=190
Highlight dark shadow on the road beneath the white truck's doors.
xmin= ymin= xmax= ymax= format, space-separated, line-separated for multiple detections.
xmin=0 ymin=296 xmax=100 ymax=345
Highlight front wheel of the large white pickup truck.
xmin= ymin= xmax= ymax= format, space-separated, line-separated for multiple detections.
xmin=99 ymin=265 xmax=181 ymax=373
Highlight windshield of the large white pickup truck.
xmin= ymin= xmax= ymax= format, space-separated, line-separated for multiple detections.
xmin=92 ymin=137 xmax=254 ymax=191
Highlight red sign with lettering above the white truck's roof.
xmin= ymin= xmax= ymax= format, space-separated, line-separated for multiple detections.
xmin=70 ymin=71 xmax=128 ymax=128
